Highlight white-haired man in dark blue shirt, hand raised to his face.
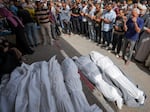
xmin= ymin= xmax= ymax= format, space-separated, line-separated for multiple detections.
xmin=122 ymin=8 xmax=144 ymax=64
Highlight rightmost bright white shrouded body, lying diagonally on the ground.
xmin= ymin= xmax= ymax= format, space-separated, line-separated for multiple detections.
xmin=90 ymin=51 xmax=145 ymax=106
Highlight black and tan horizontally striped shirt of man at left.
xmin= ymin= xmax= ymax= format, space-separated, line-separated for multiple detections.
xmin=35 ymin=9 xmax=50 ymax=24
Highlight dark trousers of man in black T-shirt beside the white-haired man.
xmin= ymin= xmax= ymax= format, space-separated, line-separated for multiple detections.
xmin=112 ymin=33 xmax=124 ymax=54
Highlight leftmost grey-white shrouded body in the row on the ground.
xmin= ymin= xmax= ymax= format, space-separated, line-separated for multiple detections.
xmin=0 ymin=67 xmax=26 ymax=112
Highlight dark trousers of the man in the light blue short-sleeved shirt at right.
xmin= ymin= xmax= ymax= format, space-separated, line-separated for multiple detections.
xmin=103 ymin=30 xmax=112 ymax=46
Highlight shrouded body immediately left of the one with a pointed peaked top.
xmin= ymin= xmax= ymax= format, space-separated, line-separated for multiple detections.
xmin=40 ymin=61 xmax=57 ymax=112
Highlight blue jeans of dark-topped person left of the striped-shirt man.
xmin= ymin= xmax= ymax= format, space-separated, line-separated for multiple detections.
xmin=25 ymin=23 xmax=39 ymax=45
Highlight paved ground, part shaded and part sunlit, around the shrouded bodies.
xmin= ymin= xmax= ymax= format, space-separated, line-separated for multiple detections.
xmin=24 ymin=34 xmax=150 ymax=112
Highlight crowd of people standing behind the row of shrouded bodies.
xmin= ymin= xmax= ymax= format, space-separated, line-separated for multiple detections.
xmin=0 ymin=0 xmax=150 ymax=77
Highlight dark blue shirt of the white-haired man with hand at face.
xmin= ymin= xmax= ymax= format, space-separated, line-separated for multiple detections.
xmin=126 ymin=17 xmax=144 ymax=41
